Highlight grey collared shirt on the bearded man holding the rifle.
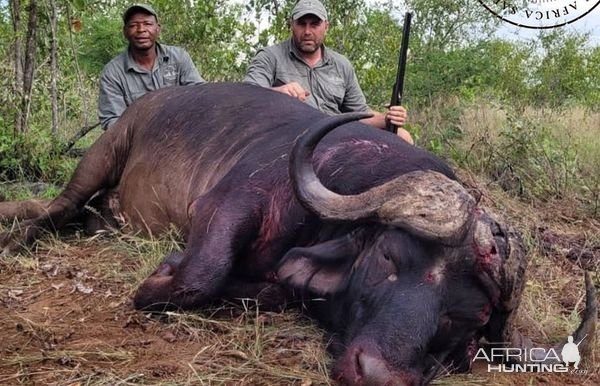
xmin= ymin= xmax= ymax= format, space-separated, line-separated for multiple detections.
xmin=244 ymin=39 xmax=370 ymax=115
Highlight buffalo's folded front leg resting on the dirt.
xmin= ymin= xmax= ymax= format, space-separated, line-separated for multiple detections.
xmin=134 ymin=194 xmax=258 ymax=311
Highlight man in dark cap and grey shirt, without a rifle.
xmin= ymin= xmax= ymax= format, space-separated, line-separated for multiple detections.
xmin=98 ymin=4 xmax=205 ymax=130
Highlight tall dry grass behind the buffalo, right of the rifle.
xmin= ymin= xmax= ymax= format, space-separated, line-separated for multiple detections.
xmin=411 ymin=99 xmax=600 ymax=220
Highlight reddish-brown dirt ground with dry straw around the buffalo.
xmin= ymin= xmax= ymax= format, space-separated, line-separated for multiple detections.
xmin=0 ymin=219 xmax=600 ymax=386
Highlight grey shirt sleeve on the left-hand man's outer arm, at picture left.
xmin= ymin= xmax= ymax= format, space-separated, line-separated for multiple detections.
xmin=98 ymin=70 xmax=127 ymax=130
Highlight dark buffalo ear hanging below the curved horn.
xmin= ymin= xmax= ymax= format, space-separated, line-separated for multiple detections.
xmin=277 ymin=235 xmax=358 ymax=295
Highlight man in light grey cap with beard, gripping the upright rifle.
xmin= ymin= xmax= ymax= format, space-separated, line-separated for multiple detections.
xmin=244 ymin=0 xmax=413 ymax=144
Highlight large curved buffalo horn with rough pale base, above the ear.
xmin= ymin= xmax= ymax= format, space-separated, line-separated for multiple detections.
xmin=290 ymin=113 xmax=475 ymax=243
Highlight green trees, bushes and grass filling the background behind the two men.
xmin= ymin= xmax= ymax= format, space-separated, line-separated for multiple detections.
xmin=0 ymin=0 xmax=600 ymax=218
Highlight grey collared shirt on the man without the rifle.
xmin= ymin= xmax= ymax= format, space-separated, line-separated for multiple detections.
xmin=98 ymin=43 xmax=205 ymax=130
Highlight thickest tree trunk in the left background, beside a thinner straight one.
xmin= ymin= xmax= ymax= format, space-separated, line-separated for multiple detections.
xmin=18 ymin=0 xmax=37 ymax=132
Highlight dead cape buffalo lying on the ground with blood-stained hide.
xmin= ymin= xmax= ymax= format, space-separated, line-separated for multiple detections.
xmin=0 ymin=84 xmax=596 ymax=385
